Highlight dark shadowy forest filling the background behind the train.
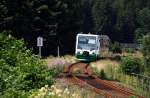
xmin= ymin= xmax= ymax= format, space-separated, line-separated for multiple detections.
xmin=0 ymin=0 xmax=150 ymax=56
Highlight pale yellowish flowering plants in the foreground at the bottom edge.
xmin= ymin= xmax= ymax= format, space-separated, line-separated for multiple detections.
xmin=29 ymin=84 xmax=105 ymax=98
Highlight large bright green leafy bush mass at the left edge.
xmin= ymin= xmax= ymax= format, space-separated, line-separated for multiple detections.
xmin=0 ymin=33 xmax=54 ymax=98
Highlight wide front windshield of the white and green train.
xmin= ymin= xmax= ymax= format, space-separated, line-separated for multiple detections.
xmin=78 ymin=36 xmax=96 ymax=50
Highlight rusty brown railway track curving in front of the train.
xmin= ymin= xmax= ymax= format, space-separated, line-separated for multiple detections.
xmin=64 ymin=62 xmax=144 ymax=98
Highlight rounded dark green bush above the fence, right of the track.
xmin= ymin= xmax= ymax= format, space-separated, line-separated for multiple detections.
xmin=120 ymin=56 xmax=143 ymax=74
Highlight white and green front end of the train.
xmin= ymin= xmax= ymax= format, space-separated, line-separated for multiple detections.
xmin=75 ymin=34 xmax=100 ymax=61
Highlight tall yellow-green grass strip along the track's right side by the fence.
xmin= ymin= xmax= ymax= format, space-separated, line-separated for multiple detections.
xmin=105 ymin=65 xmax=150 ymax=98
